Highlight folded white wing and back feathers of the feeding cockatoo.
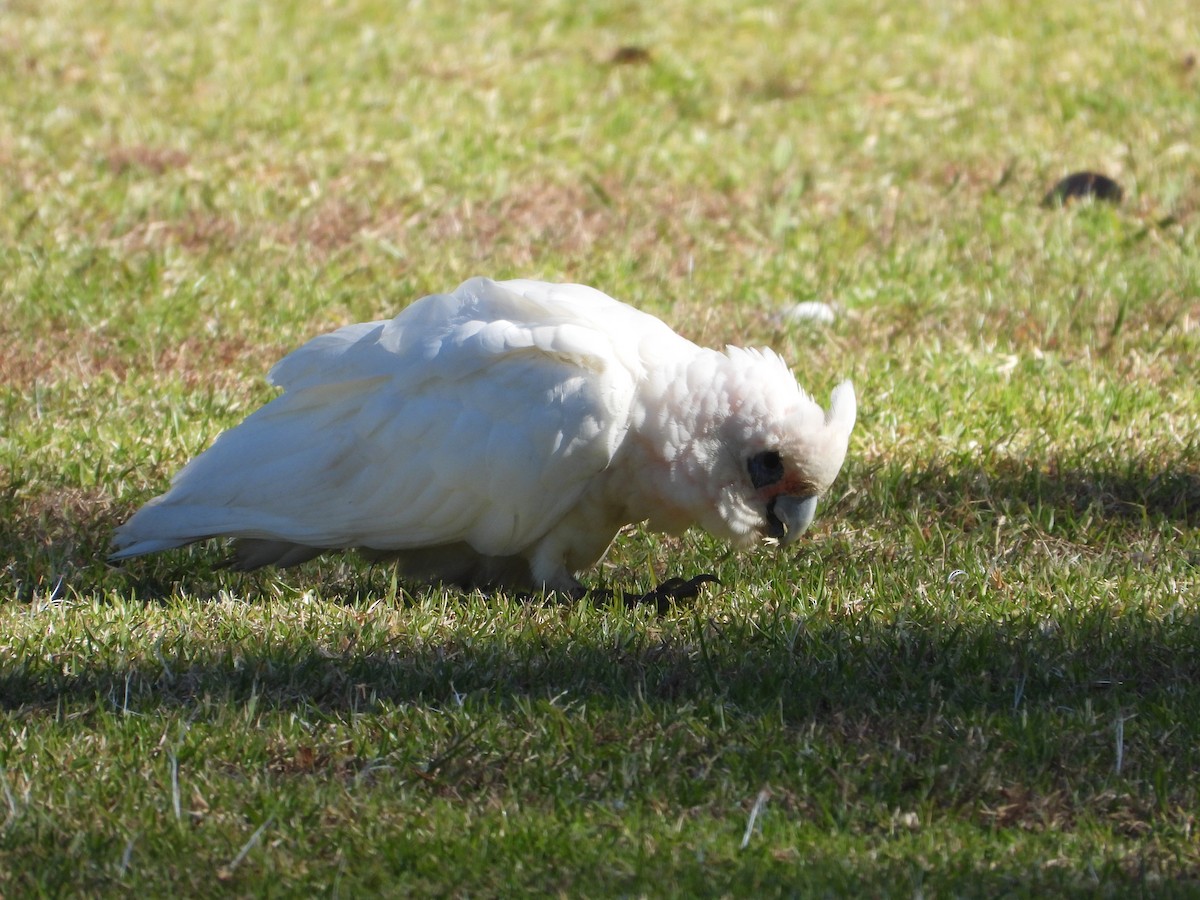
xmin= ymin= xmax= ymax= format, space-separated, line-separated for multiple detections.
xmin=114 ymin=278 xmax=657 ymax=558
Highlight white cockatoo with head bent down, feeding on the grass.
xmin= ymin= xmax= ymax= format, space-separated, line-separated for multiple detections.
xmin=112 ymin=278 xmax=856 ymax=595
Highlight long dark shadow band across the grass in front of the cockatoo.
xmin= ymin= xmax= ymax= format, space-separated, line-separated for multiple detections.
xmin=0 ymin=595 xmax=1200 ymax=721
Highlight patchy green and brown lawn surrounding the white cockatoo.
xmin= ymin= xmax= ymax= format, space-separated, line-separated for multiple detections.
xmin=0 ymin=0 xmax=1200 ymax=896
